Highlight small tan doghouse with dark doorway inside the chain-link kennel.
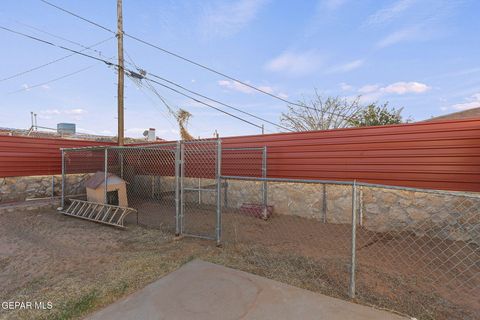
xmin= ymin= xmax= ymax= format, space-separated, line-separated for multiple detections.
xmin=85 ymin=171 xmax=128 ymax=207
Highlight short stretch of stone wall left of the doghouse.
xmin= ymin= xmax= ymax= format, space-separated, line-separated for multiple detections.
xmin=0 ymin=174 xmax=90 ymax=203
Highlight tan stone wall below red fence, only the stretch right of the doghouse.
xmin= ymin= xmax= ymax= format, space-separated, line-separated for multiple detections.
xmin=166 ymin=177 xmax=480 ymax=244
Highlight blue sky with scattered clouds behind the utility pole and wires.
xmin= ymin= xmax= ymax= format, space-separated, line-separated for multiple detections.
xmin=0 ymin=0 xmax=480 ymax=140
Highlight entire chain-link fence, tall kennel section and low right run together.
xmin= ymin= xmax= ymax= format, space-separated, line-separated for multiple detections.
xmin=63 ymin=140 xmax=480 ymax=319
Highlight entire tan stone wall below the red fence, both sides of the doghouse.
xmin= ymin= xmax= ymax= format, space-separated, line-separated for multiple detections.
xmin=0 ymin=174 xmax=480 ymax=244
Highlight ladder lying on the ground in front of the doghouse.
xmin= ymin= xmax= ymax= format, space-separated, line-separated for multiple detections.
xmin=61 ymin=199 xmax=138 ymax=228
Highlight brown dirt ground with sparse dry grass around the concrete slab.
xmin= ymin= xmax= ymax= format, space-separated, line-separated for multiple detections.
xmin=0 ymin=210 xmax=480 ymax=319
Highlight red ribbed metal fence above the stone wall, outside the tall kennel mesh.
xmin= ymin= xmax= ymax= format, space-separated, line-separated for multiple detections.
xmin=0 ymin=119 xmax=480 ymax=192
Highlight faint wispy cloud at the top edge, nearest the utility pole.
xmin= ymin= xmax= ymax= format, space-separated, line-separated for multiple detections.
xmin=200 ymin=0 xmax=268 ymax=37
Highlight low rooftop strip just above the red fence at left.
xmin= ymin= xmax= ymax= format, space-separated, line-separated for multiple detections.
xmin=0 ymin=127 xmax=165 ymax=144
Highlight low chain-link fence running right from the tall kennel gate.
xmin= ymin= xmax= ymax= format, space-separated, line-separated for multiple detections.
xmin=218 ymin=150 xmax=480 ymax=319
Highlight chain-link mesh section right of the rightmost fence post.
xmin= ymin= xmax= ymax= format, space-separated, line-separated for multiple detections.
xmin=356 ymin=187 xmax=480 ymax=319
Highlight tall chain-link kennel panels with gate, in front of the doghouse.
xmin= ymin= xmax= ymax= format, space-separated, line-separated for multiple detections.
xmin=62 ymin=140 xmax=222 ymax=244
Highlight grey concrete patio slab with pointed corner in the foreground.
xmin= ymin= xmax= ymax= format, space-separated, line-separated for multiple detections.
xmin=87 ymin=260 xmax=406 ymax=320
